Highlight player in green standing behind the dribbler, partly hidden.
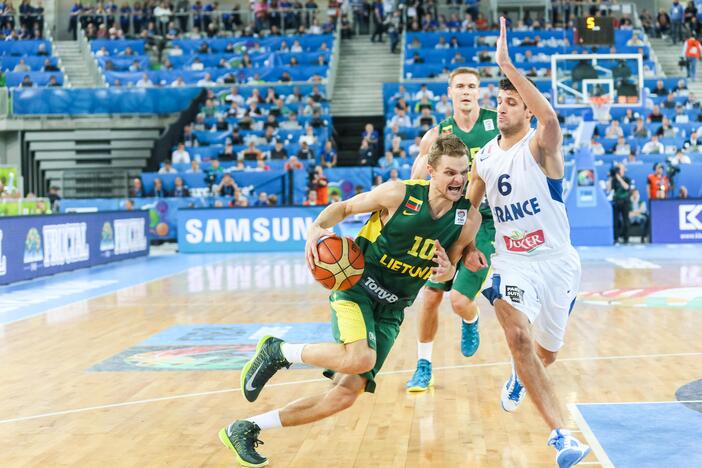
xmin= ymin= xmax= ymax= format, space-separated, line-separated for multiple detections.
xmin=406 ymin=67 xmax=499 ymax=392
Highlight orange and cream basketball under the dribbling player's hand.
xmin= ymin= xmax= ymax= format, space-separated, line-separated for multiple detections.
xmin=312 ymin=236 xmax=365 ymax=291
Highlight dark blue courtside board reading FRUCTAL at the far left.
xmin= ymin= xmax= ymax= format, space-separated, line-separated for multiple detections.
xmin=0 ymin=212 xmax=149 ymax=284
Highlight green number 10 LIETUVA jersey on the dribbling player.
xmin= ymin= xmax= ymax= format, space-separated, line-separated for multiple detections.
xmin=356 ymin=180 xmax=470 ymax=303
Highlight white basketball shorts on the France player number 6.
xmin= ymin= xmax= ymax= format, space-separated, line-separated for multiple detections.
xmin=483 ymin=247 xmax=581 ymax=352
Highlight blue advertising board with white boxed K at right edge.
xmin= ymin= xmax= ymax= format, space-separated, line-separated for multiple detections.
xmin=651 ymin=199 xmax=702 ymax=243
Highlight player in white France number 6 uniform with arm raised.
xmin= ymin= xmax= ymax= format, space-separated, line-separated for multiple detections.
xmin=466 ymin=18 xmax=590 ymax=468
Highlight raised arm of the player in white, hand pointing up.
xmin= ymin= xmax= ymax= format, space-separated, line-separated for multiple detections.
xmin=495 ymin=17 xmax=563 ymax=179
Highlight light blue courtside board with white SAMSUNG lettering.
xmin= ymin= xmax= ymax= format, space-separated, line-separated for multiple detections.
xmin=178 ymin=206 xmax=340 ymax=253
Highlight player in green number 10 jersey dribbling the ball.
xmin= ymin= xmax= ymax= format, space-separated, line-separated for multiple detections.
xmin=219 ymin=135 xmax=480 ymax=467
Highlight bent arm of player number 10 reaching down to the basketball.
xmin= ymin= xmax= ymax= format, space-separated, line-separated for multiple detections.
xmin=305 ymin=181 xmax=407 ymax=268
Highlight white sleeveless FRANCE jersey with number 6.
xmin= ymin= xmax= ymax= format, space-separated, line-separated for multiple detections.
xmin=474 ymin=129 xmax=571 ymax=257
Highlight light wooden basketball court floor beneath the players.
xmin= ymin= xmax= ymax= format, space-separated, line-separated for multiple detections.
xmin=0 ymin=248 xmax=702 ymax=467
